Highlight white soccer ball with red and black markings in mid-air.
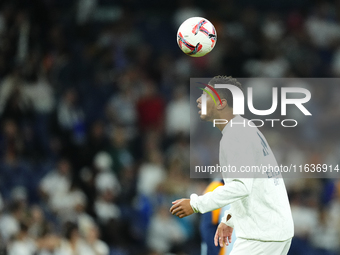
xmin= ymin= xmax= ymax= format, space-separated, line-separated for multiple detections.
xmin=177 ymin=17 xmax=217 ymax=57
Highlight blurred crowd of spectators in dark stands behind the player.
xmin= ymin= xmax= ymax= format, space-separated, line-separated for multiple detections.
xmin=0 ymin=0 xmax=340 ymax=255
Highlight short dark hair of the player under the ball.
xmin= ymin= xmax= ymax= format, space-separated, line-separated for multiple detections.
xmin=209 ymin=75 xmax=243 ymax=108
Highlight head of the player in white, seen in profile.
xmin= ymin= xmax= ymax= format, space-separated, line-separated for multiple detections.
xmin=196 ymin=75 xmax=242 ymax=121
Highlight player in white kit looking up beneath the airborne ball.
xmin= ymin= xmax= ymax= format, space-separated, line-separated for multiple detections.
xmin=170 ymin=76 xmax=294 ymax=255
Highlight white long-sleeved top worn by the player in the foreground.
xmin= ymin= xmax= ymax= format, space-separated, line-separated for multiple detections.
xmin=190 ymin=116 xmax=294 ymax=241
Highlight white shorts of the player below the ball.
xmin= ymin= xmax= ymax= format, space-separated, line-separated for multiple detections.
xmin=227 ymin=238 xmax=292 ymax=255
